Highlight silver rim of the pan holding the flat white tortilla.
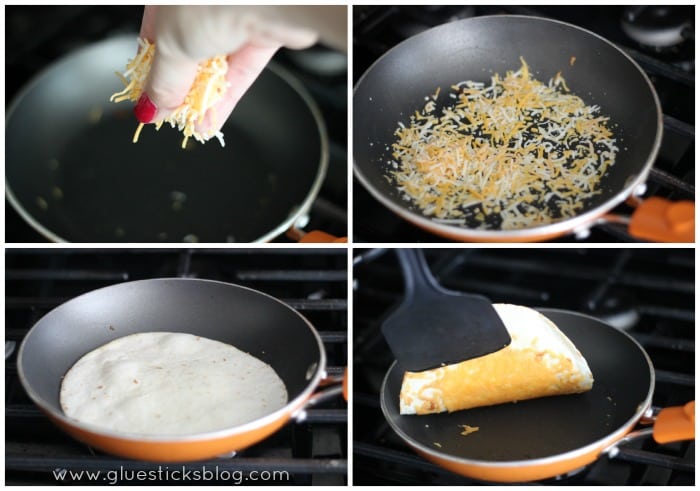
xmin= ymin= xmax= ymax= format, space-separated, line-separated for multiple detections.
xmin=17 ymin=278 xmax=327 ymax=443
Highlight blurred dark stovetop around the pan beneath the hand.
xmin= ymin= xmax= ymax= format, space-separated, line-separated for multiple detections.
xmin=5 ymin=5 xmax=348 ymax=242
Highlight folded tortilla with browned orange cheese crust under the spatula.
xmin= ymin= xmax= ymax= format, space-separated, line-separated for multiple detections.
xmin=399 ymin=304 xmax=593 ymax=414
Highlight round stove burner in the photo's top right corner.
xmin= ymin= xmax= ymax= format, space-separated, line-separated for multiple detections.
xmin=621 ymin=5 xmax=695 ymax=50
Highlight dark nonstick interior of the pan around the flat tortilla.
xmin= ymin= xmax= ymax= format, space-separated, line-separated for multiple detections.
xmin=18 ymin=279 xmax=325 ymax=420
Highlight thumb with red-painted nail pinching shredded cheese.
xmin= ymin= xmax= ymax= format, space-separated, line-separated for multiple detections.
xmin=134 ymin=49 xmax=197 ymax=123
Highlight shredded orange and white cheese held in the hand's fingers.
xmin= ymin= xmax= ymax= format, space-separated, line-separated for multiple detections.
xmin=109 ymin=39 xmax=229 ymax=148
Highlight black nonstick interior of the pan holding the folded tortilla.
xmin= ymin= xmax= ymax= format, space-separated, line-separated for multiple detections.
xmin=381 ymin=309 xmax=654 ymax=462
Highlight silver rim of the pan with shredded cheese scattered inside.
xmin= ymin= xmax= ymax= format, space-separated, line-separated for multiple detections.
xmin=353 ymin=15 xmax=663 ymax=241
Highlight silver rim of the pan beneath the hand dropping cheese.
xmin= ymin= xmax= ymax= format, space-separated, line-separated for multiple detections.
xmin=5 ymin=32 xmax=330 ymax=244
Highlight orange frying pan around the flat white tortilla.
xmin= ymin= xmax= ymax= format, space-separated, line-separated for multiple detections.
xmin=17 ymin=278 xmax=341 ymax=462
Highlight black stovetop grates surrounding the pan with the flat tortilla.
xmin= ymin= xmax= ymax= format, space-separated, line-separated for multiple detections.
xmin=5 ymin=249 xmax=348 ymax=485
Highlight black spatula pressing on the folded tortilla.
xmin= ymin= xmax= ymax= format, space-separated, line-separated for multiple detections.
xmin=382 ymin=249 xmax=510 ymax=372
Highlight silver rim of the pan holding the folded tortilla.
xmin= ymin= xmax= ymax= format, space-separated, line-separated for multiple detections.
xmin=380 ymin=307 xmax=656 ymax=477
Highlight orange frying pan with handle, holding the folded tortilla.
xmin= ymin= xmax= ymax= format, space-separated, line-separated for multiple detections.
xmin=380 ymin=309 xmax=695 ymax=482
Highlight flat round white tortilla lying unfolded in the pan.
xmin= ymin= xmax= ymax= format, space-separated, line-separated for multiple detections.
xmin=60 ymin=332 xmax=288 ymax=436
